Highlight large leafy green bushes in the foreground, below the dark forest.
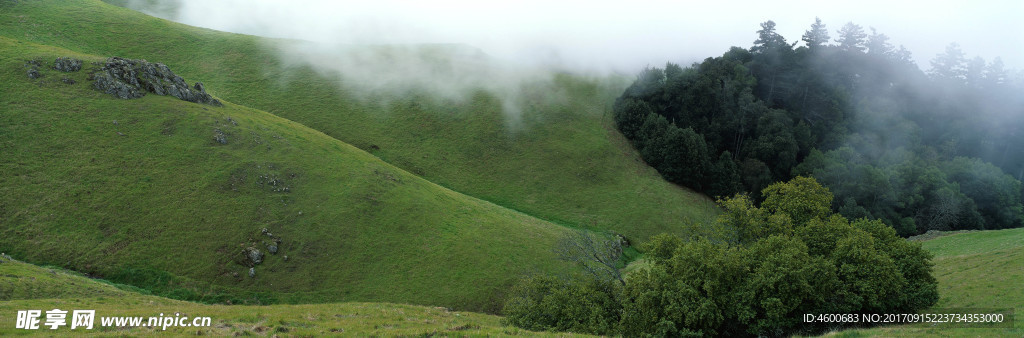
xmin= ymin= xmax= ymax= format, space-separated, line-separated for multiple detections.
xmin=506 ymin=177 xmax=938 ymax=337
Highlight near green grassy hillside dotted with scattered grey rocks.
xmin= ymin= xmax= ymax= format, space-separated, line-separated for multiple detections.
xmin=0 ymin=37 xmax=577 ymax=310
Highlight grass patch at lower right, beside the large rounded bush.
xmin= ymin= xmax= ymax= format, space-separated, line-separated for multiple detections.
xmin=834 ymin=228 xmax=1024 ymax=337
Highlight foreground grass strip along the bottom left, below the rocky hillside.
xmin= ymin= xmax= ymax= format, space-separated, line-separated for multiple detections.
xmin=0 ymin=258 xmax=585 ymax=337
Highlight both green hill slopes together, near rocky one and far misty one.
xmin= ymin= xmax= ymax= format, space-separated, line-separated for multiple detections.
xmin=0 ymin=0 xmax=716 ymax=311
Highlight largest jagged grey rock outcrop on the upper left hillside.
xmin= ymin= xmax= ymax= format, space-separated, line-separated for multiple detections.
xmin=91 ymin=56 xmax=221 ymax=107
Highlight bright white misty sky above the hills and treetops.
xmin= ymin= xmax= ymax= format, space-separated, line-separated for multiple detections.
xmin=132 ymin=0 xmax=1024 ymax=72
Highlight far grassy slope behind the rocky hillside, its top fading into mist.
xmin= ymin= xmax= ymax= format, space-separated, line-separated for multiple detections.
xmin=0 ymin=0 xmax=714 ymax=241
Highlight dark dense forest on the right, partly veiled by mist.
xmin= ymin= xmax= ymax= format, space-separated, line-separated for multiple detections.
xmin=613 ymin=19 xmax=1024 ymax=237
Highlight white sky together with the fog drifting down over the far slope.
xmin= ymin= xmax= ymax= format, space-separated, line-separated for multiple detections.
xmin=110 ymin=0 xmax=1024 ymax=125
